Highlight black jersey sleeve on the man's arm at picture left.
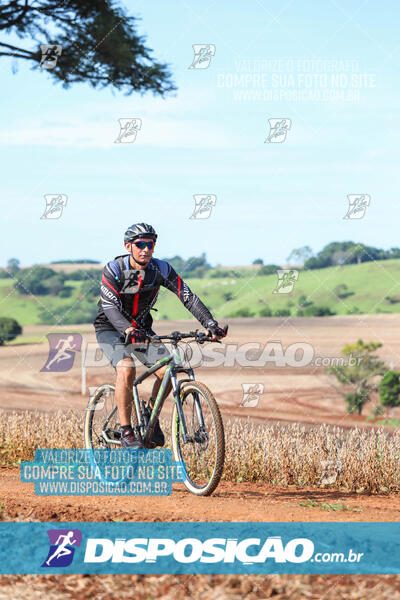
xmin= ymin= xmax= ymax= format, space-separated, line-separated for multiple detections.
xmin=100 ymin=260 xmax=131 ymax=335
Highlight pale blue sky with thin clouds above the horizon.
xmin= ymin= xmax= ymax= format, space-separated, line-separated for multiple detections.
xmin=0 ymin=0 xmax=400 ymax=265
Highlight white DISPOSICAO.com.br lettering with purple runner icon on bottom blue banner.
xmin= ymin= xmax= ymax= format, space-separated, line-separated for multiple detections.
xmin=36 ymin=527 xmax=364 ymax=573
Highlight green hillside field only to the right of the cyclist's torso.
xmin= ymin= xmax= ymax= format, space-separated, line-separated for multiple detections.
xmin=156 ymin=259 xmax=400 ymax=319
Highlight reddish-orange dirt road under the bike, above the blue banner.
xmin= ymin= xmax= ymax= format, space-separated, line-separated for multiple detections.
xmin=0 ymin=468 xmax=400 ymax=522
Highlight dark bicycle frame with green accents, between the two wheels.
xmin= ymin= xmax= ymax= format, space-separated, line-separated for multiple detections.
xmin=132 ymin=342 xmax=197 ymax=445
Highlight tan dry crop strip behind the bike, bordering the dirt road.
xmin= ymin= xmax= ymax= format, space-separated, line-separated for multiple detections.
xmin=0 ymin=410 xmax=400 ymax=493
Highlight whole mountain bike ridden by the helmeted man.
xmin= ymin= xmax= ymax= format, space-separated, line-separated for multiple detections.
xmin=84 ymin=326 xmax=228 ymax=496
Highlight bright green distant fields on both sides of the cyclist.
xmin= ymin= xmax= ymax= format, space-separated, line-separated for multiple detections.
xmin=0 ymin=259 xmax=400 ymax=325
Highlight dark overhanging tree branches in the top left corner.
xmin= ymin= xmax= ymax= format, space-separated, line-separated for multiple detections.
xmin=0 ymin=0 xmax=176 ymax=96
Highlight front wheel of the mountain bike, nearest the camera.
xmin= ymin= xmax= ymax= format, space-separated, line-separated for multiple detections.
xmin=171 ymin=381 xmax=225 ymax=496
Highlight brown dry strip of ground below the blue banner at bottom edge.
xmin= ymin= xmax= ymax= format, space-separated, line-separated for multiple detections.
xmin=0 ymin=574 xmax=400 ymax=600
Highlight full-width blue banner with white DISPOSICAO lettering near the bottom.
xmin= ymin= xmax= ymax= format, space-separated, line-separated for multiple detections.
xmin=0 ymin=522 xmax=400 ymax=574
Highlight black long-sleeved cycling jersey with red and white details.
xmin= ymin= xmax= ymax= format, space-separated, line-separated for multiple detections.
xmin=93 ymin=254 xmax=214 ymax=336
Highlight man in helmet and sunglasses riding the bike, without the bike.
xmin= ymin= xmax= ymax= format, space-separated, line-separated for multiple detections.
xmin=93 ymin=223 xmax=225 ymax=449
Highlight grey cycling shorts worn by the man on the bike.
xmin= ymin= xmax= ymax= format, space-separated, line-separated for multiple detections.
xmin=96 ymin=330 xmax=170 ymax=369
